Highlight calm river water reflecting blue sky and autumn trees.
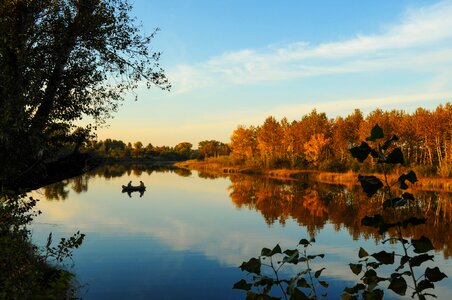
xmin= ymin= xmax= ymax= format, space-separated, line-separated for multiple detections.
xmin=32 ymin=166 xmax=452 ymax=299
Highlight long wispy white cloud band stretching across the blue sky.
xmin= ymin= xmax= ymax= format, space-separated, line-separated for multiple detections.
xmin=169 ymin=1 xmax=452 ymax=94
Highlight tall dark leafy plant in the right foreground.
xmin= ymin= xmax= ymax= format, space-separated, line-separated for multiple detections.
xmin=342 ymin=125 xmax=447 ymax=299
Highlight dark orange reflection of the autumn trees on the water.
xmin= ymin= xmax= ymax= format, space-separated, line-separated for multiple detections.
xmin=229 ymin=175 xmax=452 ymax=257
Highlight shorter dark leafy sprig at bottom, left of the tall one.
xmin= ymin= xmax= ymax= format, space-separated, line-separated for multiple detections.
xmin=233 ymin=239 xmax=328 ymax=300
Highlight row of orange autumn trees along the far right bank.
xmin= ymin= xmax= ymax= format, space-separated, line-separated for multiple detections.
xmin=229 ymin=102 xmax=452 ymax=177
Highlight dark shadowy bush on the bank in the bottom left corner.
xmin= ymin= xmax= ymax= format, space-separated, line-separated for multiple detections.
xmin=0 ymin=191 xmax=84 ymax=299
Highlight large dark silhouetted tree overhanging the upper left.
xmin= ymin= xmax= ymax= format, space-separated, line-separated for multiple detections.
xmin=0 ymin=0 xmax=170 ymax=177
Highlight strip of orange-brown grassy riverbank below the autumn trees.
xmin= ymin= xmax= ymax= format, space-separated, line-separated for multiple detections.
xmin=175 ymin=160 xmax=452 ymax=192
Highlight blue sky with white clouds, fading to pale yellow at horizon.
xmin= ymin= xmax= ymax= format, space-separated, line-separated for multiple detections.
xmin=97 ymin=0 xmax=452 ymax=148
